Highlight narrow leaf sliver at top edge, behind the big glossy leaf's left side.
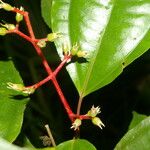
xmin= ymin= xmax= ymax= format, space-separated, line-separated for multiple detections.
xmin=41 ymin=0 xmax=52 ymax=27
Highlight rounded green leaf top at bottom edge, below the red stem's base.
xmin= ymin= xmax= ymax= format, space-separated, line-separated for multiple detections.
xmin=56 ymin=139 xmax=96 ymax=150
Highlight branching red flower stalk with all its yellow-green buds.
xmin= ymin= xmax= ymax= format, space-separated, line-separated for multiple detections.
xmin=0 ymin=0 xmax=105 ymax=134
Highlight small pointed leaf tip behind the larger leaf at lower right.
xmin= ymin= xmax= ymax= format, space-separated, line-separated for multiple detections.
xmin=129 ymin=111 xmax=147 ymax=130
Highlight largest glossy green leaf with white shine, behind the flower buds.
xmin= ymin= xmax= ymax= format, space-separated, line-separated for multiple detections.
xmin=42 ymin=0 xmax=150 ymax=98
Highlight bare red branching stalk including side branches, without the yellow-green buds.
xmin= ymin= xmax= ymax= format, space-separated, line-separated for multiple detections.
xmin=7 ymin=8 xmax=91 ymax=122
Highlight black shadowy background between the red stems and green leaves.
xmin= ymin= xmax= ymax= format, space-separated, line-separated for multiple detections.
xmin=0 ymin=0 xmax=150 ymax=150
